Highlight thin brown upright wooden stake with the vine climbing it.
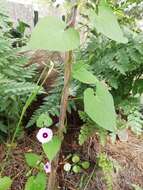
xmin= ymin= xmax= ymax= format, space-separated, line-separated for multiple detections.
xmin=47 ymin=0 xmax=77 ymax=190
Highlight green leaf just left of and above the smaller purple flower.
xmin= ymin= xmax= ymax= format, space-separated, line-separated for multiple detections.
xmin=25 ymin=153 xmax=41 ymax=168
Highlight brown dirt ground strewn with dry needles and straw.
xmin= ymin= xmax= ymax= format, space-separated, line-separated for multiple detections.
xmin=0 ymin=128 xmax=143 ymax=190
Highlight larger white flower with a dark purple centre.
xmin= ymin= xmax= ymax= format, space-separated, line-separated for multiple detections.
xmin=36 ymin=128 xmax=53 ymax=144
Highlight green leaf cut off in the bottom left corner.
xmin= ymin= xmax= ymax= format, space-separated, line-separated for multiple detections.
xmin=0 ymin=176 xmax=12 ymax=190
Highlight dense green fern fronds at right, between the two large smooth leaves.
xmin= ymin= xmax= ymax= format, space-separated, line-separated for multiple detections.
xmin=80 ymin=34 xmax=143 ymax=99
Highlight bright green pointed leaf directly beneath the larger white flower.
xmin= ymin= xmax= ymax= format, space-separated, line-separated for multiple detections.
xmin=42 ymin=136 xmax=61 ymax=161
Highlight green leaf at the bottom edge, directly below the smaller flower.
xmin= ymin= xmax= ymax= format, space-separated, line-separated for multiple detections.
xmin=25 ymin=173 xmax=47 ymax=190
